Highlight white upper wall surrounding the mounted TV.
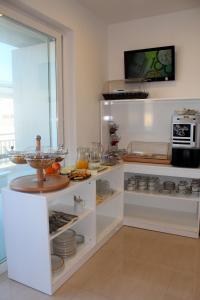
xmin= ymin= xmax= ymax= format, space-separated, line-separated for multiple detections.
xmin=108 ymin=8 xmax=200 ymax=98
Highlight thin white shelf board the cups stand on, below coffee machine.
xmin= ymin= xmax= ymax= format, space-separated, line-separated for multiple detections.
xmin=124 ymin=191 xmax=200 ymax=202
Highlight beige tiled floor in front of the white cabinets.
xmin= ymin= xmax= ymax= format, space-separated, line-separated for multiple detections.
xmin=0 ymin=227 xmax=200 ymax=300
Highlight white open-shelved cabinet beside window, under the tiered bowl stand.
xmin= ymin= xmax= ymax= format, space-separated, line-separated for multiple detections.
xmin=3 ymin=165 xmax=123 ymax=295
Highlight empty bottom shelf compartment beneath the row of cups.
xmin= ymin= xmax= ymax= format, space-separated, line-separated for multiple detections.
xmin=124 ymin=204 xmax=199 ymax=237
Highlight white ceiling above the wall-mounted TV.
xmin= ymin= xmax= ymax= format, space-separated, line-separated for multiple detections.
xmin=78 ymin=0 xmax=200 ymax=24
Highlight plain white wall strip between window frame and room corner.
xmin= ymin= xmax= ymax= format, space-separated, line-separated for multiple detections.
xmin=7 ymin=0 xmax=107 ymax=151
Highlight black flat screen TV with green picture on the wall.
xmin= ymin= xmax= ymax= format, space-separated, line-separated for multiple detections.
xmin=124 ymin=46 xmax=175 ymax=82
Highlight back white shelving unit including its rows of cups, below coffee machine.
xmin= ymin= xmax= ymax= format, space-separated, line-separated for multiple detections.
xmin=124 ymin=163 xmax=200 ymax=238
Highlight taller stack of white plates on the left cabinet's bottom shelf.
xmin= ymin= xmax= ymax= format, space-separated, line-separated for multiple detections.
xmin=53 ymin=229 xmax=76 ymax=258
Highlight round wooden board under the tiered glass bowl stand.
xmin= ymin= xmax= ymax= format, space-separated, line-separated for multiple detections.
xmin=10 ymin=175 xmax=70 ymax=193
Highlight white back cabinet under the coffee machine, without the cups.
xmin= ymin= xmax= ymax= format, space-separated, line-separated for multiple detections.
xmin=124 ymin=163 xmax=200 ymax=238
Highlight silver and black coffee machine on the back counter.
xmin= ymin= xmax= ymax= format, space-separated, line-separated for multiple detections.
xmin=171 ymin=110 xmax=200 ymax=168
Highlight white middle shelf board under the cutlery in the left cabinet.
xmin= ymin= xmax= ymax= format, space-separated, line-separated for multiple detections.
xmin=49 ymin=205 xmax=92 ymax=240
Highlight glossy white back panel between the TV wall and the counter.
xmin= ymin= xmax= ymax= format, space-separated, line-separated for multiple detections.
xmin=102 ymin=98 xmax=200 ymax=149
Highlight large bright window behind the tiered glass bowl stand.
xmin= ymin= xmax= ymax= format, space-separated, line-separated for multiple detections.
xmin=0 ymin=11 xmax=63 ymax=263
